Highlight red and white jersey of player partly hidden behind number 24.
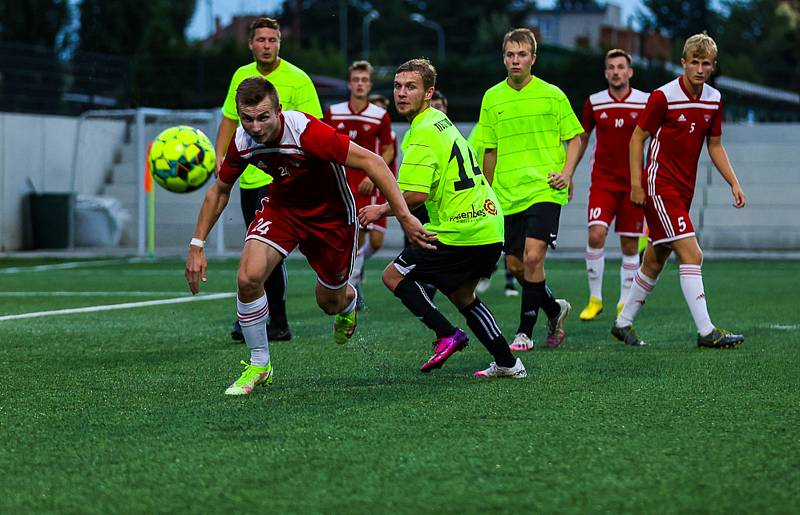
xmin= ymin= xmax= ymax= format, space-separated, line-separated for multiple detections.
xmin=322 ymin=102 xmax=392 ymax=191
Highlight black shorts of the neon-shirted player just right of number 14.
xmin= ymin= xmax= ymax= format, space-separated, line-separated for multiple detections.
xmin=503 ymin=202 xmax=561 ymax=254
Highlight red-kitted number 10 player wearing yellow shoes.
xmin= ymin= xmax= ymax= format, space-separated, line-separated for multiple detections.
xmin=580 ymin=49 xmax=648 ymax=320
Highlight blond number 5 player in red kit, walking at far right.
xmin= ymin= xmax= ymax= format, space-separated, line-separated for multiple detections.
xmin=611 ymin=33 xmax=746 ymax=348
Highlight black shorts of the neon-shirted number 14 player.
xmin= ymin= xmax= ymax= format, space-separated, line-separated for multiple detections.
xmin=394 ymin=243 xmax=503 ymax=295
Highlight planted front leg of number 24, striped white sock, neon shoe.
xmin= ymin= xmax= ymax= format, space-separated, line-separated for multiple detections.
xmin=225 ymin=240 xmax=283 ymax=395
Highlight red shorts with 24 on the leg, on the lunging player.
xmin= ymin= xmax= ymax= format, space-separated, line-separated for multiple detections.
xmin=245 ymin=198 xmax=358 ymax=290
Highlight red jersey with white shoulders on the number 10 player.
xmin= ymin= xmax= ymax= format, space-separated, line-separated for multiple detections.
xmin=581 ymin=88 xmax=649 ymax=191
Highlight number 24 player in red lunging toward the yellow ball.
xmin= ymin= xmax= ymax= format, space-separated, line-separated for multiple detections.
xmin=185 ymin=77 xmax=433 ymax=395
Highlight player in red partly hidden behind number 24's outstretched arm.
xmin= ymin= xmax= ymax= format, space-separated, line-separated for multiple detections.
xmin=323 ymin=61 xmax=395 ymax=309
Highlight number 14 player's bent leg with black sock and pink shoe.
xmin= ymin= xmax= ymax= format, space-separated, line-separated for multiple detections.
xmin=382 ymin=245 xmax=469 ymax=372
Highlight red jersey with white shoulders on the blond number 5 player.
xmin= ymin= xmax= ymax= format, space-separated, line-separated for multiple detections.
xmin=638 ymin=76 xmax=722 ymax=200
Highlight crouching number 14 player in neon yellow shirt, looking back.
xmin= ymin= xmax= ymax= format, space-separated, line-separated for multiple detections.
xmin=359 ymin=59 xmax=527 ymax=379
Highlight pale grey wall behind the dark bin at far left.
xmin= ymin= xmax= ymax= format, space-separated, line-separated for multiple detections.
xmin=0 ymin=113 xmax=125 ymax=251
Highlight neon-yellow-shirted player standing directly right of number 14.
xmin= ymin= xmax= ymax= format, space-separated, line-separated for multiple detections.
xmin=478 ymin=29 xmax=583 ymax=351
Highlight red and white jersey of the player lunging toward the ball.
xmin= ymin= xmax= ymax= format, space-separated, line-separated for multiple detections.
xmin=219 ymin=111 xmax=356 ymax=223
